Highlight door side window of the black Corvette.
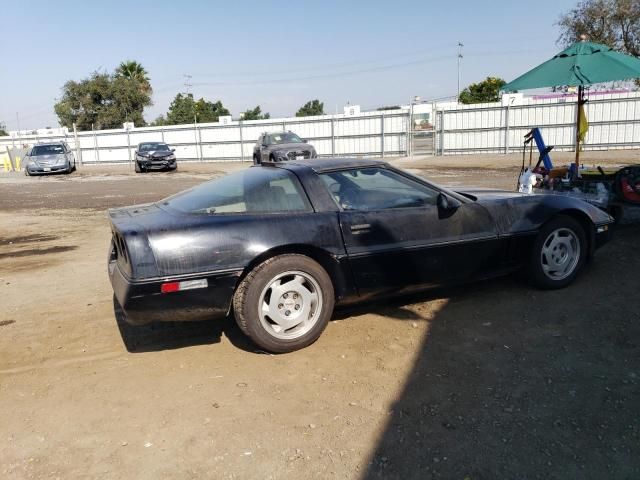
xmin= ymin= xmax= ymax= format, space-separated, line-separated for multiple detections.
xmin=321 ymin=168 xmax=439 ymax=210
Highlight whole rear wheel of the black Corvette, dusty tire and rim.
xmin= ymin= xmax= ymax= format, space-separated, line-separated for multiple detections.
xmin=233 ymin=254 xmax=335 ymax=353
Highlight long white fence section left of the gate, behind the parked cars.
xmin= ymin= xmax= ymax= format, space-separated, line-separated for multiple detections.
xmin=0 ymin=109 xmax=408 ymax=164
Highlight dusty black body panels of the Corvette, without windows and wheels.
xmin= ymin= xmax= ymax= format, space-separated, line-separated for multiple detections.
xmin=108 ymin=159 xmax=612 ymax=334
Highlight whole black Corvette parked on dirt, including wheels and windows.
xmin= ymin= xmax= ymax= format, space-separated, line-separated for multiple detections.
xmin=108 ymin=159 xmax=612 ymax=352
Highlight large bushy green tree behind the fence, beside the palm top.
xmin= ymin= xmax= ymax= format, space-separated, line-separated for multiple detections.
xmin=54 ymin=67 xmax=152 ymax=130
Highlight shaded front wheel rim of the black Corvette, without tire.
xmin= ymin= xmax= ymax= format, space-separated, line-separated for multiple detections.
xmin=540 ymin=228 xmax=580 ymax=280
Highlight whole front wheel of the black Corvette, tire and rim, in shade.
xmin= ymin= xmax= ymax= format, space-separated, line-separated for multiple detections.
xmin=529 ymin=215 xmax=588 ymax=290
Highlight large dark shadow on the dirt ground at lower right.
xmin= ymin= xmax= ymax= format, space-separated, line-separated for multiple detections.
xmin=363 ymin=226 xmax=640 ymax=480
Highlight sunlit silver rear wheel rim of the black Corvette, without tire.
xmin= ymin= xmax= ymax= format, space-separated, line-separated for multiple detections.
xmin=258 ymin=270 xmax=322 ymax=340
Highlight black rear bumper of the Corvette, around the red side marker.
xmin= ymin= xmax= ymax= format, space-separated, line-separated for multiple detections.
xmin=108 ymin=261 xmax=242 ymax=325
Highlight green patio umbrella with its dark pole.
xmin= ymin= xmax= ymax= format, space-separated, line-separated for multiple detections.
xmin=502 ymin=40 xmax=640 ymax=165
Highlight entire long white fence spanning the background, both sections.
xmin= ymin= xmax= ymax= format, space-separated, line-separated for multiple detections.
xmin=0 ymin=92 xmax=640 ymax=163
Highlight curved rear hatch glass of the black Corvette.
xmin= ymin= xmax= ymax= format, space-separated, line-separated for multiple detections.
xmin=160 ymin=167 xmax=311 ymax=214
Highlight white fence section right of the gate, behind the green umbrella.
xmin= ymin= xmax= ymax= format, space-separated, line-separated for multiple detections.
xmin=435 ymin=92 xmax=640 ymax=155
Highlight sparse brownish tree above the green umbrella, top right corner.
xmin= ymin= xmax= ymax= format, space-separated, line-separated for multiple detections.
xmin=558 ymin=0 xmax=640 ymax=57
